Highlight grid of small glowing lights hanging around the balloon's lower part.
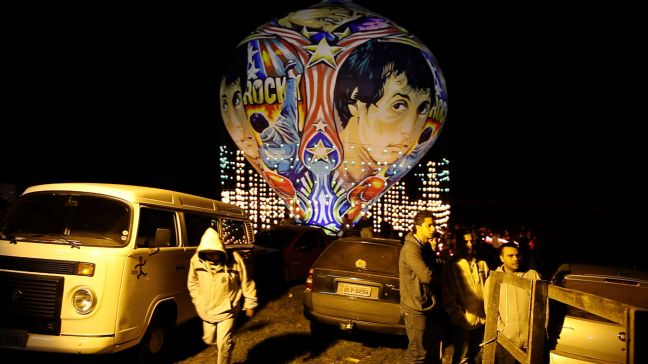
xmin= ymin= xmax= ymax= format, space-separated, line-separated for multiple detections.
xmin=219 ymin=146 xmax=450 ymax=237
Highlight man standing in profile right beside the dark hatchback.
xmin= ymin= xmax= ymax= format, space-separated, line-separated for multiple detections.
xmin=398 ymin=211 xmax=443 ymax=364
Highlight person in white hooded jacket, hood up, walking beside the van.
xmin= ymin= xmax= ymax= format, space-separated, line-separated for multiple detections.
xmin=187 ymin=228 xmax=258 ymax=364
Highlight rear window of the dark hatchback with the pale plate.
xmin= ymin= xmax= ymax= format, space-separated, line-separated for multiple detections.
xmin=318 ymin=240 xmax=401 ymax=276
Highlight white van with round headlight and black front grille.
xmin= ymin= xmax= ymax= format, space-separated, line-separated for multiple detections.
xmin=0 ymin=183 xmax=254 ymax=357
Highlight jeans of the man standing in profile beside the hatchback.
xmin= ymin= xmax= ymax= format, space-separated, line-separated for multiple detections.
xmin=403 ymin=312 xmax=443 ymax=364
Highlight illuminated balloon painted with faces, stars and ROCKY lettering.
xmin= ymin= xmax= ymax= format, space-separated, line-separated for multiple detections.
xmin=220 ymin=2 xmax=447 ymax=230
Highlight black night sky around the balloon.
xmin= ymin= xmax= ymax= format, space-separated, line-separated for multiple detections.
xmin=6 ymin=0 xmax=648 ymax=270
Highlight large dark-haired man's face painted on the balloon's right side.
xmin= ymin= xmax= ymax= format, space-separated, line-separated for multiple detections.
xmin=351 ymin=73 xmax=432 ymax=163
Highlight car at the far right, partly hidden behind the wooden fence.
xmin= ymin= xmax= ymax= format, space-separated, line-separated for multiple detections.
xmin=549 ymin=264 xmax=648 ymax=364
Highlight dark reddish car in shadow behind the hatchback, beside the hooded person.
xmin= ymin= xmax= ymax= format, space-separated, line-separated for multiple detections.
xmin=252 ymin=225 xmax=334 ymax=284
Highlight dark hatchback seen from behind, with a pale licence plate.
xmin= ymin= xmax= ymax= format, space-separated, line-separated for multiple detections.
xmin=304 ymin=237 xmax=405 ymax=335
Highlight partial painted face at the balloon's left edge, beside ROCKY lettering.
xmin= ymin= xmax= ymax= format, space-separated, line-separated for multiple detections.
xmin=220 ymin=78 xmax=259 ymax=159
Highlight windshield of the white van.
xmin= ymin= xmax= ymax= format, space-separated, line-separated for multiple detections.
xmin=1 ymin=192 xmax=131 ymax=247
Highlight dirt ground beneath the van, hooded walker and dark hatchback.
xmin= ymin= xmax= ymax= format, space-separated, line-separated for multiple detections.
xmin=0 ymin=284 xmax=452 ymax=364
